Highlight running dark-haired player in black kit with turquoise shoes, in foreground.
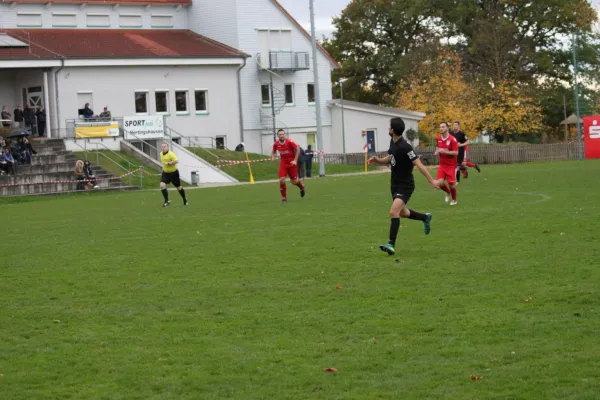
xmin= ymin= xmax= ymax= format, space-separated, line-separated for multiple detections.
xmin=369 ymin=118 xmax=439 ymax=256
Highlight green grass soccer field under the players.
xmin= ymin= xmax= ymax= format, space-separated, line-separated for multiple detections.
xmin=0 ymin=161 xmax=600 ymax=400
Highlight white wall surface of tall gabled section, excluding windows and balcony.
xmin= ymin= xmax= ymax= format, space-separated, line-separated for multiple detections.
xmin=189 ymin=0 xmax=332 ymax=148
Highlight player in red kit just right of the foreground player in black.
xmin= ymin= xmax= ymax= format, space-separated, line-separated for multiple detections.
xmin=435 ymin=122 xmax=458 ymax=206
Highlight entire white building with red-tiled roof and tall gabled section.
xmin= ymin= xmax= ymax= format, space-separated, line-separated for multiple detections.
xmin=0 ymin=0 xmax=424 ymax=153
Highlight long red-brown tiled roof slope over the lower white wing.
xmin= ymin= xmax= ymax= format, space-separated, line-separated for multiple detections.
xmin=0 ymin=29 xmax=248 ymax=60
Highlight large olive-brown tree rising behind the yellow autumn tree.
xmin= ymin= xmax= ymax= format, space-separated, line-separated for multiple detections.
xmin=439 ymin=0 xmax=597 ymax=84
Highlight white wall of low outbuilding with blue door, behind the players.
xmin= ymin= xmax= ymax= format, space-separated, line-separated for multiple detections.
xmin=330 ymin=106 xmax=419 ymax=153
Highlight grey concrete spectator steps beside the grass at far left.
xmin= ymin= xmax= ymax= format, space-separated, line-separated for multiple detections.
xmin=0 ymin=139 xmax=139 ymax=196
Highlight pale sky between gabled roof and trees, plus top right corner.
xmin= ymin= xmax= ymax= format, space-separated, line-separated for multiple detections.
xmin=279 ymin=0 xmax=600 ymax=39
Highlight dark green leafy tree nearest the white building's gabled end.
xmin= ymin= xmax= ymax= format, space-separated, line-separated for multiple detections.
xmin=323 ymin=0 xmax=437 ymax=104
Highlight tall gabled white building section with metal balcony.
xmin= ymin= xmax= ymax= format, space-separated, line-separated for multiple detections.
xmin=189 ymin=0 xmax=341 ymax=153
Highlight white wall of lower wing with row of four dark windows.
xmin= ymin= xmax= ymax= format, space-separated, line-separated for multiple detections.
xmin=58 ymin=66 xmax=240 ymax=144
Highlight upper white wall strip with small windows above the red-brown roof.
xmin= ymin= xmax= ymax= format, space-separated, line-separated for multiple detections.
xmin=0 ymin=3 xmax=187 ymax=29
